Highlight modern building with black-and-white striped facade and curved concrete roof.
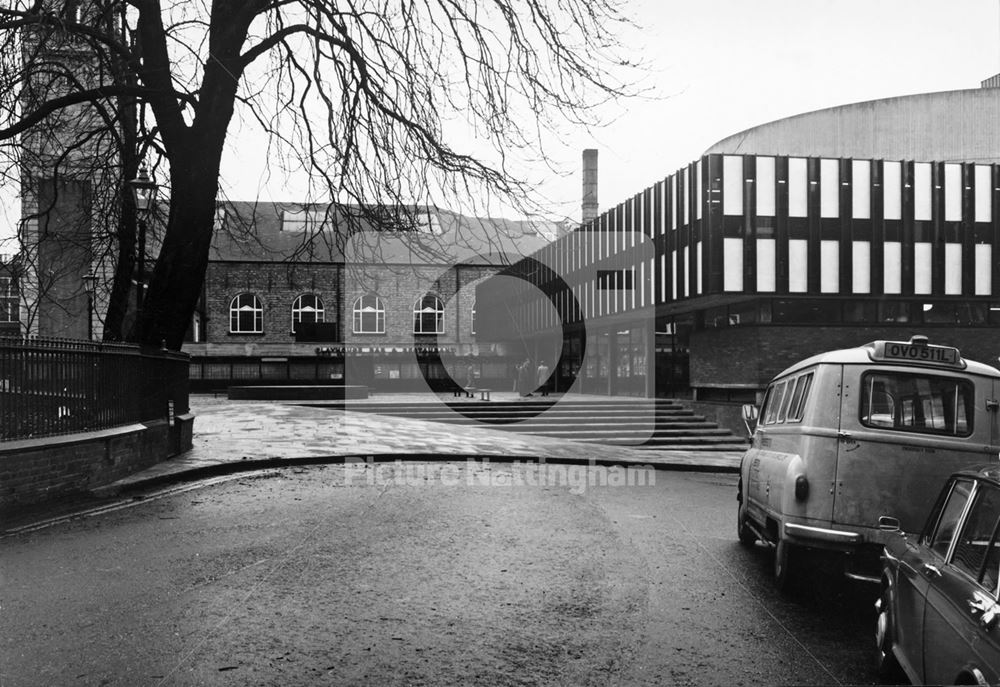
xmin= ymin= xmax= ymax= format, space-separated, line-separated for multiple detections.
xmin=479 ymin=88 xmax=1000 ymax=403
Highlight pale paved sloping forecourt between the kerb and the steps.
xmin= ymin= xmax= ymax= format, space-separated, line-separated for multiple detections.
xmin=94 ymin=392 xmax=741 ymax=495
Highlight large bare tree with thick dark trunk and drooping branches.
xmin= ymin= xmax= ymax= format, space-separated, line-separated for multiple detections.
xmin=0 ymin=0 xmax=634 ymax=349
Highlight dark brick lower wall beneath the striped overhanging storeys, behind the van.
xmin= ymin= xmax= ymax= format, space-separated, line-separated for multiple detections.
xmin=691 ymin=325 xmax=1000 ymax=388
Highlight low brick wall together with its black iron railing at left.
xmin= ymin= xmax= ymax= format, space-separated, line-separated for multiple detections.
xmin=0 ymin=338 xmax=193 ymax=511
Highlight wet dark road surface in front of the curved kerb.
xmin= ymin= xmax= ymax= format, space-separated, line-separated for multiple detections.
xmin=0 ymin=462 xmax=875 ymax=686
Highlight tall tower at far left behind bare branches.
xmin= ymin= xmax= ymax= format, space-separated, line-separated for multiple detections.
xmin=19 ymin=0 xmax=118 ymax=339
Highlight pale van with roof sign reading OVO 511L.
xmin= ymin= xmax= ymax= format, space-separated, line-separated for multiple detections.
xmin=737 ymin=336 xmax=1000 ymax=586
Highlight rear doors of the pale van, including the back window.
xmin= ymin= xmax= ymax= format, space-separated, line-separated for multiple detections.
xmin=833 ymin=365 xmax=996 ymax=532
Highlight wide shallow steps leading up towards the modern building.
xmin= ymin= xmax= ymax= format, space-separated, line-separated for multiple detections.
xmin=347 ymin=399 xmax=747 ymax=451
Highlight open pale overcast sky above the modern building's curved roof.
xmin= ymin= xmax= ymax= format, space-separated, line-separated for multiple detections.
xmin=0 ymin=0 xmax=1000 ymax=245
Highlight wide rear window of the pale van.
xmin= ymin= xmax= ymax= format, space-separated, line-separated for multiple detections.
xmin=859 ymin=372 xmax=975 ymax=436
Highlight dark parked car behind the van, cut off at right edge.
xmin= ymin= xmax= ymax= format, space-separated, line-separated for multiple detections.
xmin=875 ymin=465 xmax=1000 ymax=685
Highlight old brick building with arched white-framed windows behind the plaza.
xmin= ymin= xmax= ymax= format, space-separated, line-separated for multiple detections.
xmin=183 ymin=202 xmax=559 ymax=389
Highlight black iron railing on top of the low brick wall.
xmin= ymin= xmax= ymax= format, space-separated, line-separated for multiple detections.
xmin=0 ymin=338 xmax=189 ymax=441
